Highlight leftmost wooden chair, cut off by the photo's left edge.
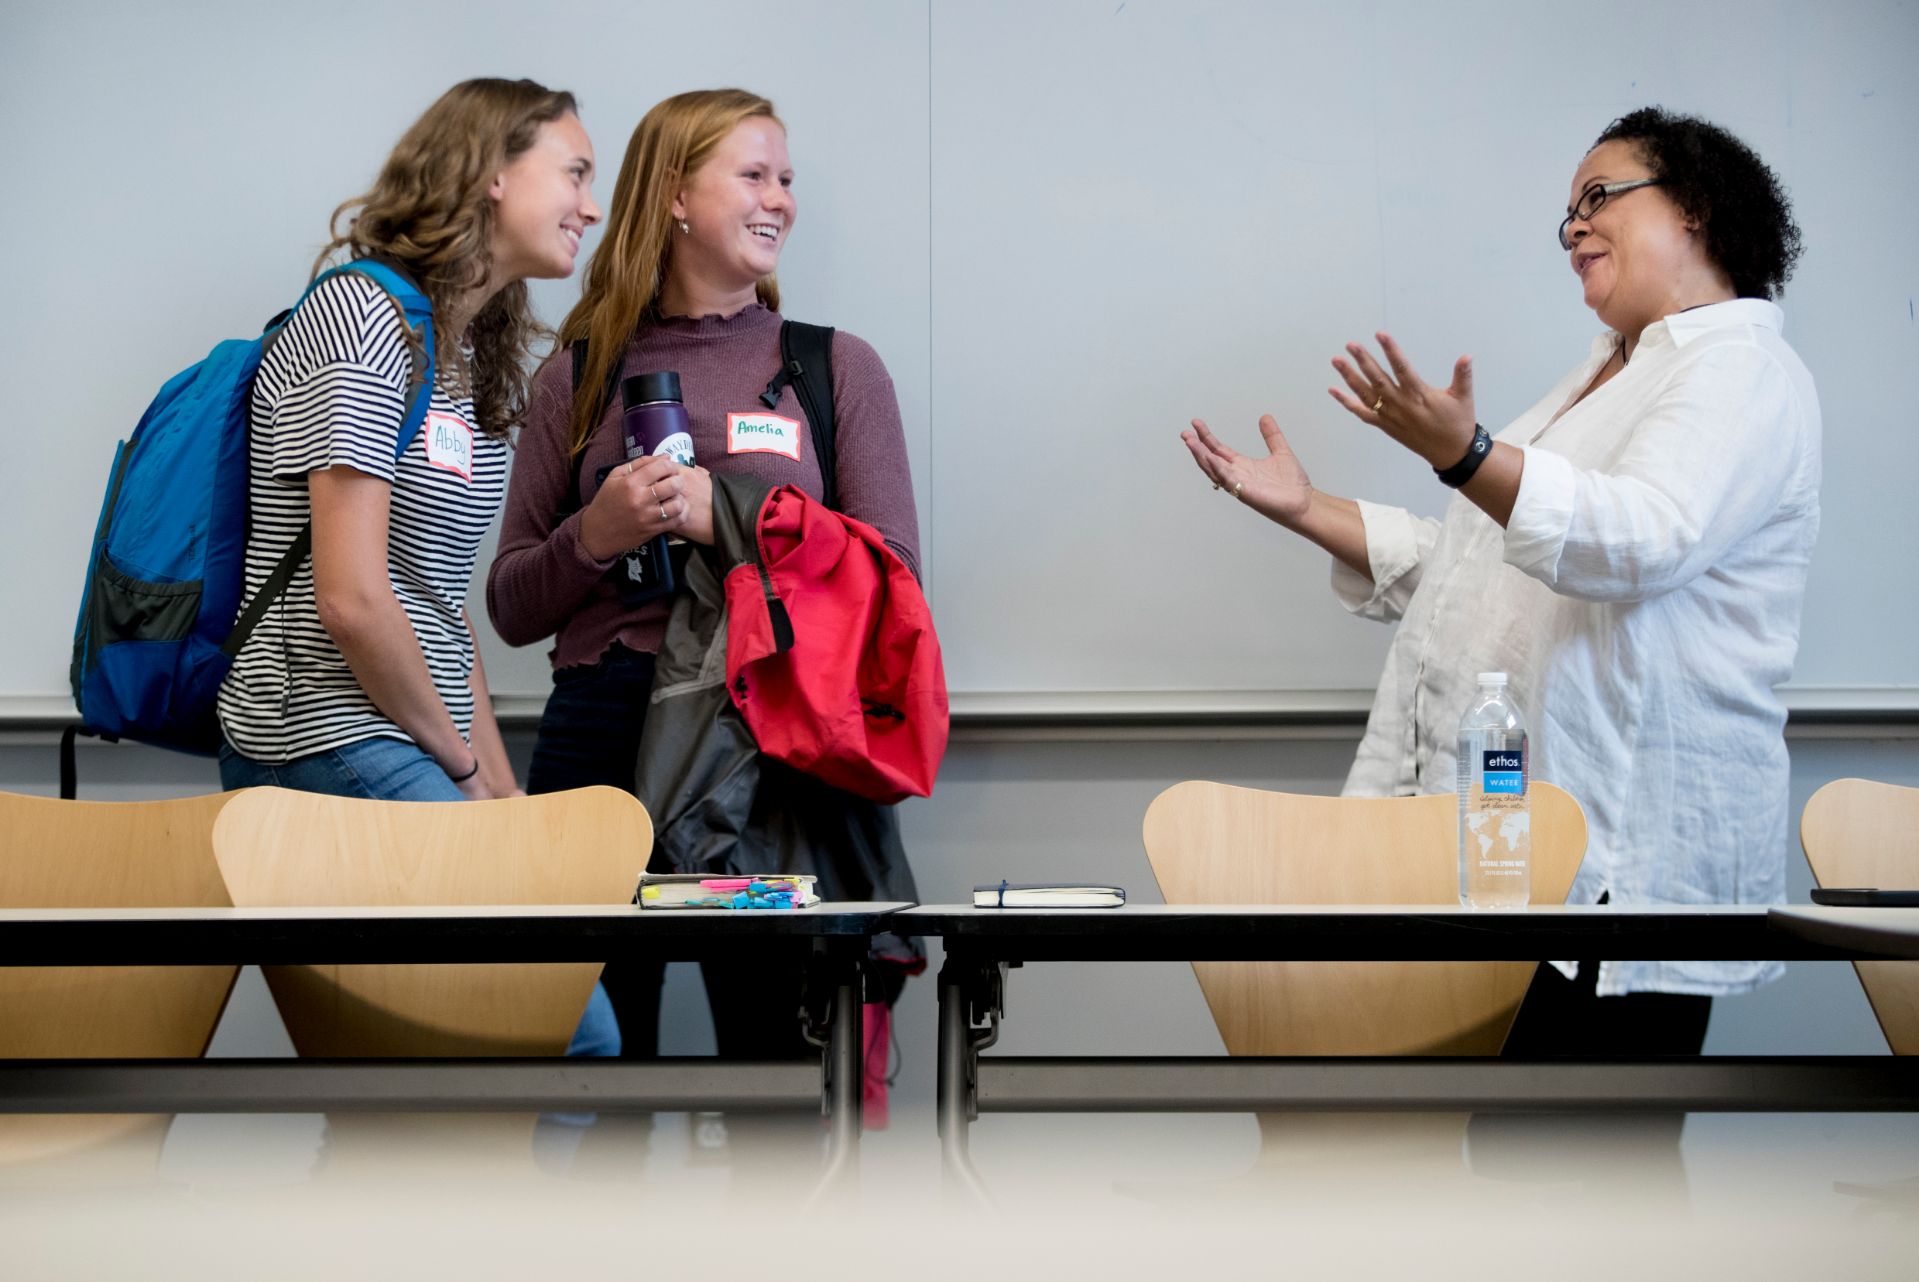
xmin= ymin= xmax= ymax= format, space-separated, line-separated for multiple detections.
xmin=0 ymin=793 xmax=238 ymax=1173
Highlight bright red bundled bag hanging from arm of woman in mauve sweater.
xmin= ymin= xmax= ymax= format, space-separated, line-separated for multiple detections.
xmin=725 ymin=486 xmax=948 ymax=802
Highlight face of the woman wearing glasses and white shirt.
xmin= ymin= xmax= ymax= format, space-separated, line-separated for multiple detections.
xmin=1566 ymin=140 xmax=1719 ymax=340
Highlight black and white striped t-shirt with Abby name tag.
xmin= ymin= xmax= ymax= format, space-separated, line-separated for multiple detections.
xmin=219 ymin=264 xmax=507 ymax=762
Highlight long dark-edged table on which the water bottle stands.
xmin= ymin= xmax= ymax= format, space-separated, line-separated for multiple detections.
xmin=892 ymin=904 xmax=1919 ymax=1192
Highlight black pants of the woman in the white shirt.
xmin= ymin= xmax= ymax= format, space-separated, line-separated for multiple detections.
xmin=1466 ymin=962 xmax=1712 ymax=1207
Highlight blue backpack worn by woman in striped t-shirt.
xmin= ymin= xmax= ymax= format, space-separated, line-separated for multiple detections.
xmin=69 ymin=259 xmax=434 ymax=756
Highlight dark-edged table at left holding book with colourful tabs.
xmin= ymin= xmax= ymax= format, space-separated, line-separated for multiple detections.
xmin=0 ymin=902 xmax=908 ymax=1182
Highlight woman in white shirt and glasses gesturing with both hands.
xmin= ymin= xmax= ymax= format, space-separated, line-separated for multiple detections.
xmin=1182 ymin=107 xmax=1819 ymax=1056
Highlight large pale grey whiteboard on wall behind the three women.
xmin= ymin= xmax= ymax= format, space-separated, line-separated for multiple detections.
xmin=0 ymin=0 xmax=1919 ymax=716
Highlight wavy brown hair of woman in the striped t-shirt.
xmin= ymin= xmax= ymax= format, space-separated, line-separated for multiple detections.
xmin=313 ymin=79 xmax=580 ymax=439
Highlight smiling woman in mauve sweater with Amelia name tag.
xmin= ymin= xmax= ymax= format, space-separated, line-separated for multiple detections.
xmin=487 ymin=90 xmax=919 ymax=1082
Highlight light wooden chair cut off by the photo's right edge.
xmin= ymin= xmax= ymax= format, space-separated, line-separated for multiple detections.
xmin=1800 ymin=779 xmax=1919 ymax=1056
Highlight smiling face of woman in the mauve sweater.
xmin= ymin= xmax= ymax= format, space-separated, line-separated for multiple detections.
xmin=668 ymin=115 xmax=798 ymax=294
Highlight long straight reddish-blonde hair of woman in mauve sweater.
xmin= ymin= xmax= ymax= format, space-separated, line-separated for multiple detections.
xmin=553 ymin=88 xmax=785 ymax=453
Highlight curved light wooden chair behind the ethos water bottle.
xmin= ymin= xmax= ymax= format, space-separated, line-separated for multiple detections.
xmin=1144 ymin=781 xmax=1585 ymax=1056
